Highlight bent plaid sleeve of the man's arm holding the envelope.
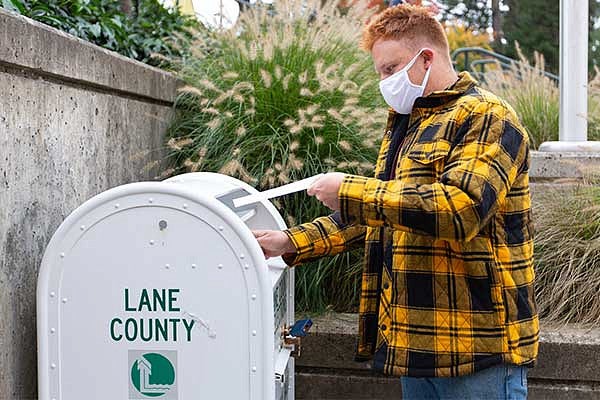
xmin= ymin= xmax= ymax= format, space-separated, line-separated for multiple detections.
xmin=339 ymin=102 xmax=529 ymax=241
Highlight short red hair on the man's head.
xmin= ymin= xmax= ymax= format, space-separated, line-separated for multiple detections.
xmin=361 ymin=4 xmax=449 ymax=51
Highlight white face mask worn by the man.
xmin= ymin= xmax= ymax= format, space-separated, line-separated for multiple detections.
xmin=379 ymin=49 xmax=431 ymax=114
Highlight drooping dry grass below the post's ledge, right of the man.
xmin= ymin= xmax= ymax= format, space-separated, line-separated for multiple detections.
xmin=533 ymin=181 xmax=600 ymax=326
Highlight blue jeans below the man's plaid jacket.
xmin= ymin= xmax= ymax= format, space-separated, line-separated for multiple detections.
xmin=401 ymin=364 xmax=527 ymax=400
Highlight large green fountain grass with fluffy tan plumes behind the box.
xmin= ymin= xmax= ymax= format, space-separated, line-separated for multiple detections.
xmin=163 ymin=0 xmax=386 ymax=311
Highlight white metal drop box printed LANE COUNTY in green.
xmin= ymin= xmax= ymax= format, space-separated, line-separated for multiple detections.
xmin=37 ymin=173 xmax=302 ymax=400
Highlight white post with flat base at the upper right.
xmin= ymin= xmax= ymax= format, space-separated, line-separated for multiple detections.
xmin=540 ymin=0 xmax=600 ymax=152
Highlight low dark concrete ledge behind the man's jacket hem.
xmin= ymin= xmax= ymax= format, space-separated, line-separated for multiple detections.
xmin=296 ymin=314 xmax=600 ymax=400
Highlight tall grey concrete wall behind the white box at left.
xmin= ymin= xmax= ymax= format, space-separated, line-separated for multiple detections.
xmin=0 ymin=9 xmax=177 ymax=400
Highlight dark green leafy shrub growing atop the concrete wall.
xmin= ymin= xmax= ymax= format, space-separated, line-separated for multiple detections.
xmin=2 ymin=0 xmax=200 ymax=67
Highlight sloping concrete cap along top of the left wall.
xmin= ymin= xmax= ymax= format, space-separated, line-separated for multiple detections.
xmin=0 ymin=8 xmax=178 ymax=105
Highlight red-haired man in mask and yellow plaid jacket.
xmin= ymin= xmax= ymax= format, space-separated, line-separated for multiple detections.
xmin=255 ymin=5 xmax=538 ymax=399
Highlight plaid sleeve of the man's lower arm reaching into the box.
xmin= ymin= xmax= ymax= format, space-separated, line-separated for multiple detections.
xmin=283 ymin=212 xmax=366 ymax=266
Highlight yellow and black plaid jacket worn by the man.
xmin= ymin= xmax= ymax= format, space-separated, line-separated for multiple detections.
xmin=284 ymin=73 xmax=539 ymax=377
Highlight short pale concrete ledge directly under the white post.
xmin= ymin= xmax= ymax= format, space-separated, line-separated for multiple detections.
xmin=529 ymin=151 xmax=600 ymax=181
